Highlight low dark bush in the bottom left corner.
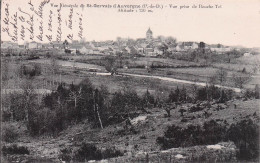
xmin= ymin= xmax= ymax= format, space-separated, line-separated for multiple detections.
xmin=2 ymin=144 xmax=30 ymax=156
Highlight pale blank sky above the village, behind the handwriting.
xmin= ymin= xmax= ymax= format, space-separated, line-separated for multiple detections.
xmin=1 ymin=0 xmax=260 ymax=47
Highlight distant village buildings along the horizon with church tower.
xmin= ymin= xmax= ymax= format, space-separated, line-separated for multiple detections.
xmin=1 ymin=28 xmax=231 ymax=56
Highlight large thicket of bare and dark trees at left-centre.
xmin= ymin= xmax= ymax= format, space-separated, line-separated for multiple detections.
xmin=3 ymin=79 xmax=155 ymax=136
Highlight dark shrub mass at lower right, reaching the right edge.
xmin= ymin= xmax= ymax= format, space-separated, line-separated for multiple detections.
xmin=156 ymin=118 xmax=259 ymax=160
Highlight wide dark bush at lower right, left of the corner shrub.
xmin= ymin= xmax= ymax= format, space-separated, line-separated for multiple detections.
xmin=156 ymin=120 xmax=226 ymax=149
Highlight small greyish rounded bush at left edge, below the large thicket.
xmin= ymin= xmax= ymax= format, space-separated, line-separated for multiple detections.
xmin=2 ymin=125 xmax=18 ymax=143
